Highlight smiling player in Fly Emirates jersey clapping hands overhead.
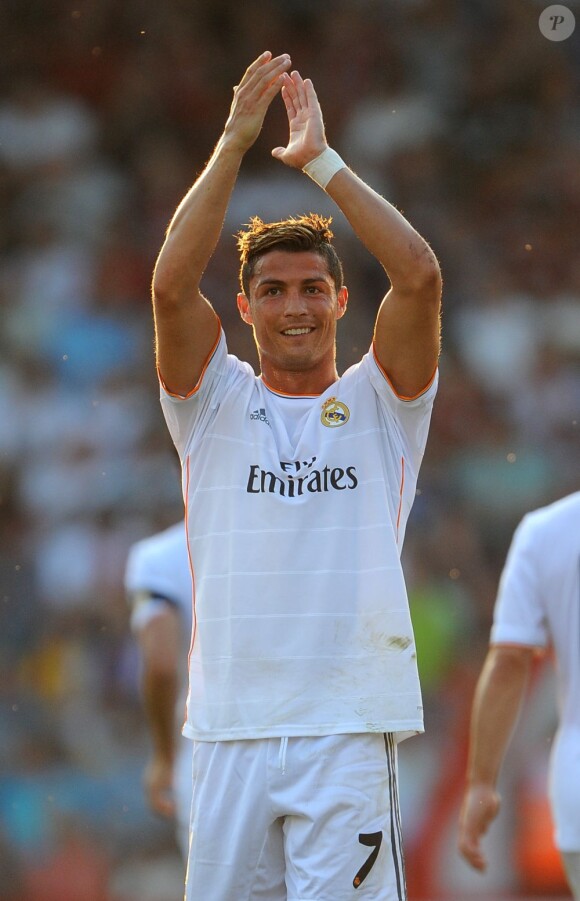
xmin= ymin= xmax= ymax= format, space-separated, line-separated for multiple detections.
xmin=153 ymin=53 xmax=441 ymax=901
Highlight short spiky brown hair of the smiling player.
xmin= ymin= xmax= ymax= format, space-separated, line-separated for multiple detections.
xmin=236 ymin=213 xmax=343 ymax=297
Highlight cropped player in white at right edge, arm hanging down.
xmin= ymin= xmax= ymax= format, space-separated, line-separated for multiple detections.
xmin=459 ymin=492 xmax=580 ymax=901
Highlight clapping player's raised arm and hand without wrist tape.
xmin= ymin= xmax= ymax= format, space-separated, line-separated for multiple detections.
xmin=153 ymin=52 xmax=290 ymax=395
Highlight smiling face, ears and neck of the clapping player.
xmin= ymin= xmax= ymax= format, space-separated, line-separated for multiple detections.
xmin=238 ymin=250 xmax=348 ymax=394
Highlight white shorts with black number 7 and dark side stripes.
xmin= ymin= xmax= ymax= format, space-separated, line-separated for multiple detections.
xmin=185 ymin=733 xmax=407 ymax=901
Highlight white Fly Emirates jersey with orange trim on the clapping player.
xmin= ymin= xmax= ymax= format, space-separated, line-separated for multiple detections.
xmin=161 ymin=333 xmax=436 ymax=741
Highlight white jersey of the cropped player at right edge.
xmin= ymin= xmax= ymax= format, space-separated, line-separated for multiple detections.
xmin=491 ymin=492 xmax=580 ymax=851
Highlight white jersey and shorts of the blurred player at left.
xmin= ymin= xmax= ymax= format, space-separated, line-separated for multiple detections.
xmin=125 ymin=521 xmax=193 ymax=859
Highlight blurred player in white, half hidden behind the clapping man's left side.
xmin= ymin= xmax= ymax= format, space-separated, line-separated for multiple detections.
xmin=125 ymin=521 xmax=192 ymax=861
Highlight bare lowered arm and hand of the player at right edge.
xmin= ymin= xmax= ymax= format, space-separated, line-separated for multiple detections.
xmin=458 ymin=645 xmax=534 ymax=870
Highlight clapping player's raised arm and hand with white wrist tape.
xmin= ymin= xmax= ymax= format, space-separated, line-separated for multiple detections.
xmin=272 ymin=72 xmax=441 ymax=397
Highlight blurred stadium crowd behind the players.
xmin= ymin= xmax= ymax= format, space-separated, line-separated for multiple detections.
xmin=0 ymin=0 xmax=580 ymax=901
